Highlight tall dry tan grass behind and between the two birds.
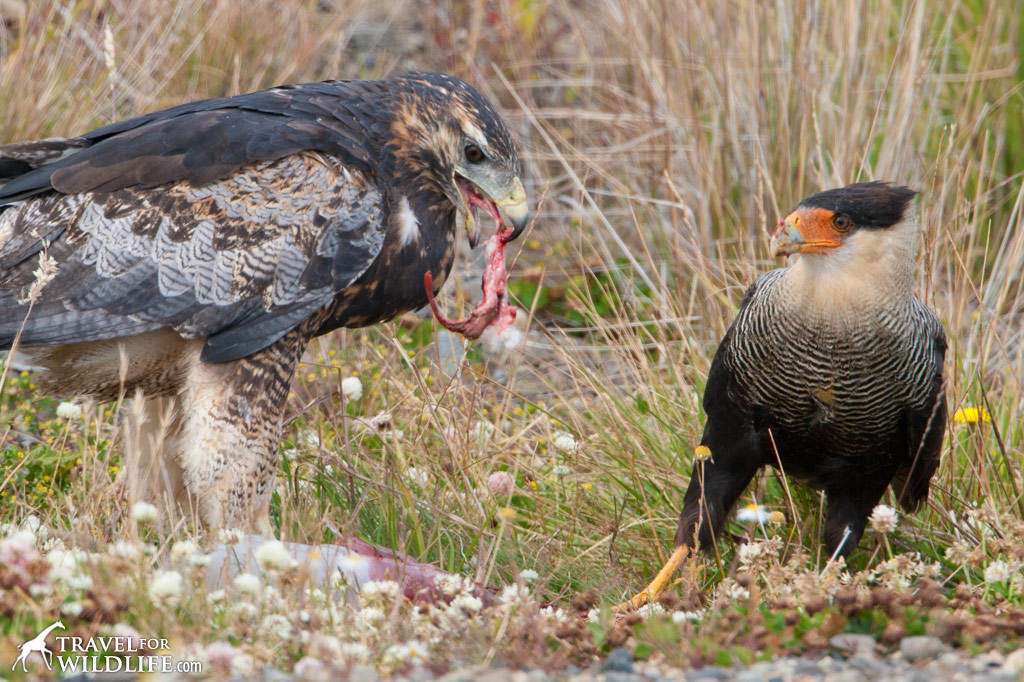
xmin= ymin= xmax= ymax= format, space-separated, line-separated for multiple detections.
xmin=0 ymin=0 xmax=1024 ymax=663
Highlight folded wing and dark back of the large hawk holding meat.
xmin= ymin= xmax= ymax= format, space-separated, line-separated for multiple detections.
xmin=0 ymin=83 xmax=386 ymax=361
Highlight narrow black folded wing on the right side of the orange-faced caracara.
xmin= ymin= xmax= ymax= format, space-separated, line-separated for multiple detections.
xmin=893 ymin=300 xmax=946 ymax=511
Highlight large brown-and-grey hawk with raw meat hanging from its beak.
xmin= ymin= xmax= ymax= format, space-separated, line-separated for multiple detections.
xmin=0 ymin=73 xmax=528 ymax=531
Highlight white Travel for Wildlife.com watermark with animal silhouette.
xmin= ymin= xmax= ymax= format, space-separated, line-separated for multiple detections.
xmin=10 ymin=621 xmax=203 ymax=674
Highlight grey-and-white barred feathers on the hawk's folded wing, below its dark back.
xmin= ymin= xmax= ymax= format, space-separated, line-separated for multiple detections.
xmin=0 ymin=110 xmax=384 ymax=360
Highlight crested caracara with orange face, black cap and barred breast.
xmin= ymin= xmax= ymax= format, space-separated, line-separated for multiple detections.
xmin=614 ymin=182 xmax=946 ymax=605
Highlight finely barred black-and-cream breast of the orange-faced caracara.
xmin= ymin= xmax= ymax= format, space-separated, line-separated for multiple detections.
xmin=725 ymin=269 xmax=941 ymax=457
